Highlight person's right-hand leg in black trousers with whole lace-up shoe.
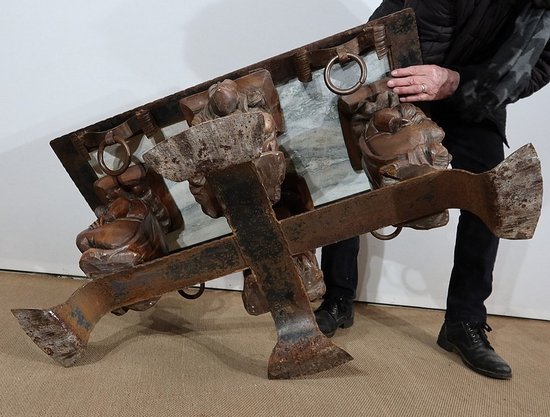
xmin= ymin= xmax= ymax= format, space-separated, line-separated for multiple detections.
xmin=437 ymin=119 xmax=512 ymax=379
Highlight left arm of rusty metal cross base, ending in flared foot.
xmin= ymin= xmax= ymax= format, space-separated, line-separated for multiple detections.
xmin=12 ymin=237 xmax=246 ymax=366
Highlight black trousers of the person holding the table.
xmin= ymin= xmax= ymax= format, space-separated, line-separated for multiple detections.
xmin=321 ymin=118 xmax=504 ymax=322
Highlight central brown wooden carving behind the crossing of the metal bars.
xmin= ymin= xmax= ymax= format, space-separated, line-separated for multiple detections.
xmin=180 ymin=70 xmax=325 ymax=315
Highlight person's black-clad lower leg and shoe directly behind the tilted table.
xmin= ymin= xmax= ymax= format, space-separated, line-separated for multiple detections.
xmin=315 ymin=236 xmax=359 ymax=337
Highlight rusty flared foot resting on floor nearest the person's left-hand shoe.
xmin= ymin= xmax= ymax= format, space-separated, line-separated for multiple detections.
xmin=268 ymin=333 xmax=353 ymax=379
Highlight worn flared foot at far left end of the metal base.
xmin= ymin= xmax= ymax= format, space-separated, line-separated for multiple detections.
xmin=11 ymin=309 xmax=86 ymax=367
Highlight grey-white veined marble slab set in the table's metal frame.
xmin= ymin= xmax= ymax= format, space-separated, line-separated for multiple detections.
xmin=94 ymin=53 xmax=389 ymax=250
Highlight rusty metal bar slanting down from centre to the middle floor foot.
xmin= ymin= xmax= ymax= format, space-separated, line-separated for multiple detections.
xmin=208 ymin=163 xmax=352 ymax=379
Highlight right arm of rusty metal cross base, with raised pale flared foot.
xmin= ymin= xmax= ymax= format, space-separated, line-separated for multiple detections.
xmin=283 ymin=144 xmax=542 ymax=253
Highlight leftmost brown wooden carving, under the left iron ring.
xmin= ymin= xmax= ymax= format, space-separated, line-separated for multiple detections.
xmin=76 ymin=165 xmax=172 ymax=315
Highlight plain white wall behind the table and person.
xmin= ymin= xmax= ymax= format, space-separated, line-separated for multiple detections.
xmin=0 ymin=0 xmax=550 ymax=320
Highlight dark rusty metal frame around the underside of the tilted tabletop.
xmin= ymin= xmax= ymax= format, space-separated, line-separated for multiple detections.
xmin=50 ymin=9 xmax=421 ymax=209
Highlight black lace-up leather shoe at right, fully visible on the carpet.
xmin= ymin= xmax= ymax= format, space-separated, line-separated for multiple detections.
xmin=437 ymin=321 xmax=512 ymax=379
